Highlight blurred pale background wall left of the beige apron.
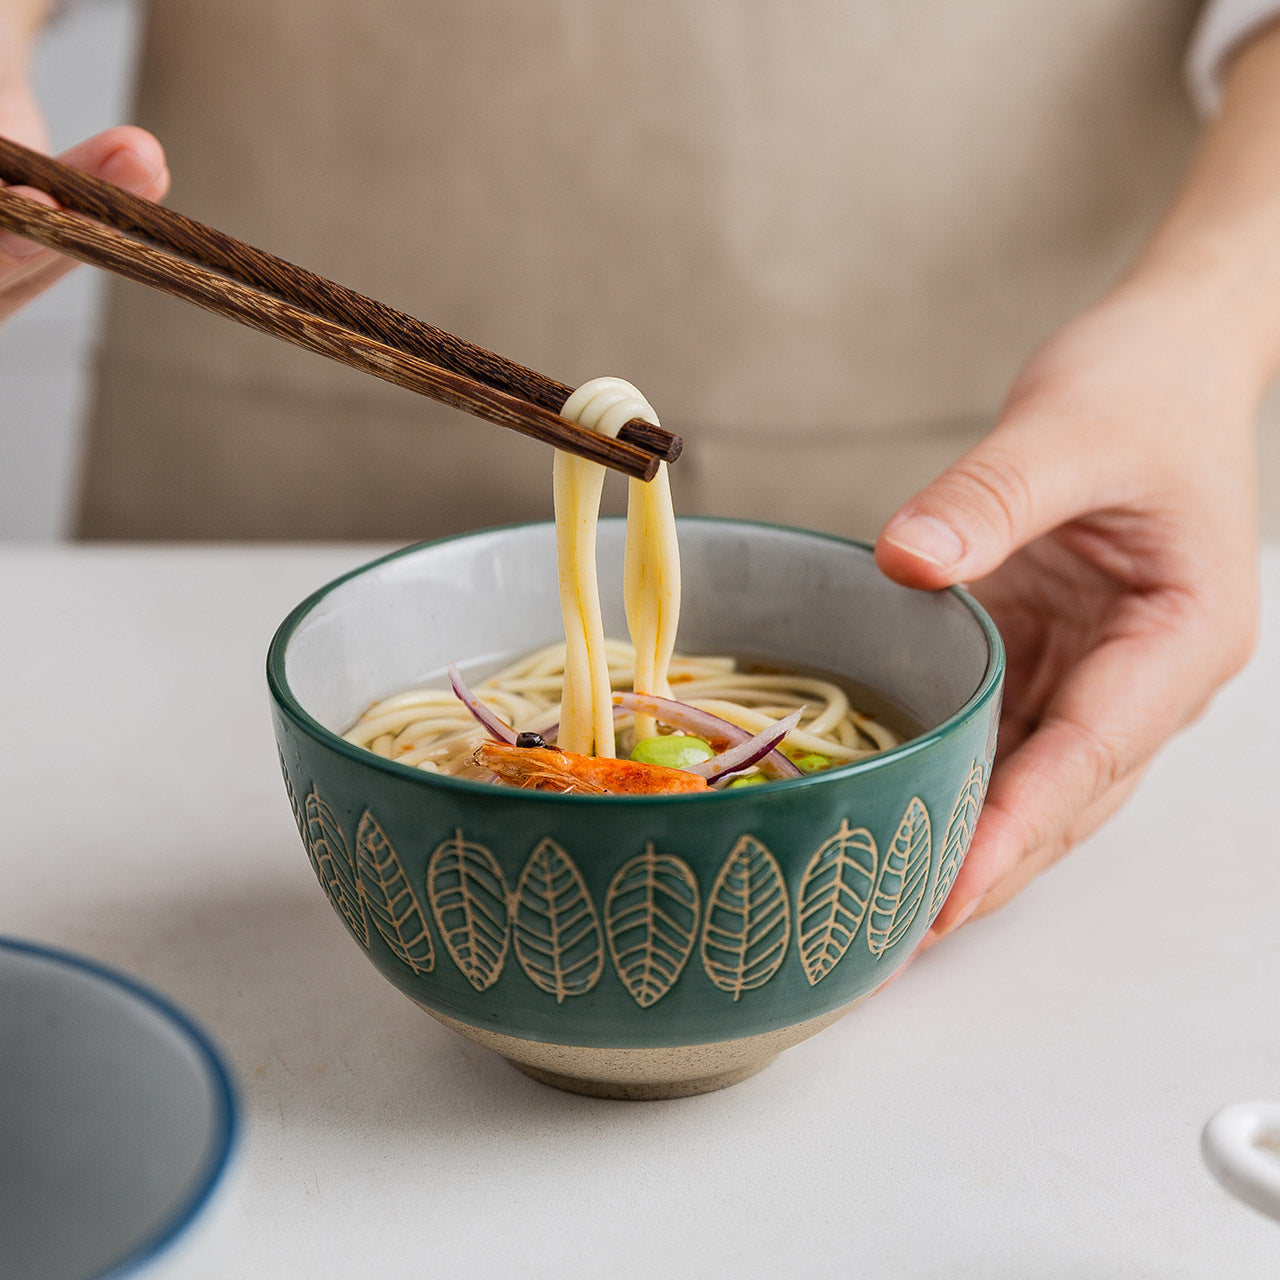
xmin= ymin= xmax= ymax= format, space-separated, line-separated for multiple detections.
xmin=0 ymin=0 xmax=138 ymax=540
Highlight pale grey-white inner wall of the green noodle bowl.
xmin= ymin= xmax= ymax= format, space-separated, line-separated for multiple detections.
xmin=285 ymin=520 xmax=991 ymax=732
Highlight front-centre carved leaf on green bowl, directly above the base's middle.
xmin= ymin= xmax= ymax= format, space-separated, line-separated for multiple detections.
xmin=604 ymin=841 xmax=699 ymax=1009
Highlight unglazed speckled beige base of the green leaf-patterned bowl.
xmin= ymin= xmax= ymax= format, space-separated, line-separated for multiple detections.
xmin=420 ymin=996 xmax=867 ymax=1102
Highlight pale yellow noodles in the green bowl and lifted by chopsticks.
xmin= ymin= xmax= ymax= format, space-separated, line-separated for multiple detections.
xmin=344 ymin=378 xmax=899 ymax=780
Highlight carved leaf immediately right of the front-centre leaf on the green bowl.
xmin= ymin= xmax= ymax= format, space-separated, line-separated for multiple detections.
xmin=701 ymin=835 xmax=791 ymax=1000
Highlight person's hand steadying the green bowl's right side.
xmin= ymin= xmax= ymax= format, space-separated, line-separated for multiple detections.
xmin=876 ymin=271 xmax=1263 ymax=946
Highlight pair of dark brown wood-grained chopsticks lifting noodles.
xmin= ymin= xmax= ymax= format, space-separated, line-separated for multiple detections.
xmin=0 ymin=138 xmax=682 ymax=480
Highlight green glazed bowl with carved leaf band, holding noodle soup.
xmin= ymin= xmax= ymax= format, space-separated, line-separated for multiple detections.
xmin=268 ymin=520 xmax=1005 ymax=1098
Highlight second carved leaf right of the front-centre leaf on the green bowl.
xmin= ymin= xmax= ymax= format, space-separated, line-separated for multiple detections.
xmin=796 ymin=819 xmax=877 ymax=987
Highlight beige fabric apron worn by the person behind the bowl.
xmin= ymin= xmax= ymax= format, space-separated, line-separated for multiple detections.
xmin=82 ymin=0 xmax=1198 ymax=539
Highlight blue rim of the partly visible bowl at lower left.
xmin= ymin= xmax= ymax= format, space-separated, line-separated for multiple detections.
xmin=0 ymin=934 xmax=243 ymax=1280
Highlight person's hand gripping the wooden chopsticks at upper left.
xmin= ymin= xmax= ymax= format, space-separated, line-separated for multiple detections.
xmin=0 ymin=13 xmax=169 ymax=321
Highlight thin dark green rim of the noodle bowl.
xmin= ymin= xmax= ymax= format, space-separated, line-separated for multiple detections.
xmin=266 ymin=516 xmax=1005 ymax=806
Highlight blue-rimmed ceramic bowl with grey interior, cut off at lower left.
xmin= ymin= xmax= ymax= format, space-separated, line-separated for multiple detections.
xmin=0 ymin=938 xmax=238 ymax=1280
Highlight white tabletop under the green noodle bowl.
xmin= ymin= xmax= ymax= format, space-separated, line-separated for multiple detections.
xmin=0 ymin=547 xmax=1280 ymax=1280
